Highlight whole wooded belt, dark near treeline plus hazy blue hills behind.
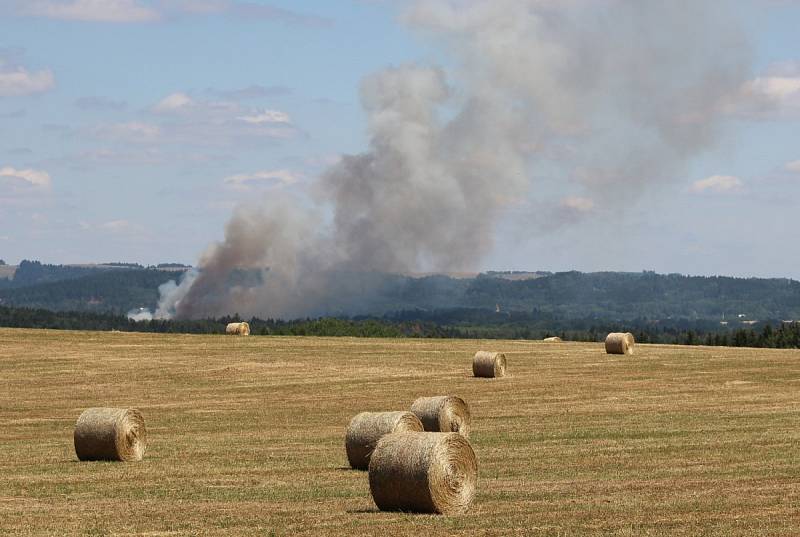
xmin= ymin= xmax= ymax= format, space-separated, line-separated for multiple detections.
xmin=0 ymin=261 xmax=800 ymax=348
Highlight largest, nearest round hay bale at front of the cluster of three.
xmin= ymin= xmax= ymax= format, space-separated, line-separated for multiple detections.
xmin=369 ymin=432 xmax=478 ymax=515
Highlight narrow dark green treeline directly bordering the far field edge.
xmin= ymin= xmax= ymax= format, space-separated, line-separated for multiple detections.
xmin=0 ymin=306 xmax=800 ymax=349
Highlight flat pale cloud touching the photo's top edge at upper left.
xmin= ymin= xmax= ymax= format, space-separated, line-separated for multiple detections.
xmin=20 ymin=0 xmax=161 ymax=23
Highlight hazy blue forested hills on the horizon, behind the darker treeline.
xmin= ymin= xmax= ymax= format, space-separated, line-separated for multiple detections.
xmin=0 ymin=261 xmax=800 ymax=322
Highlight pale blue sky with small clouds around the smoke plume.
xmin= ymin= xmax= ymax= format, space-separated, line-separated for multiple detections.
xmin=0 ymin=0 xmax=800 ymax=279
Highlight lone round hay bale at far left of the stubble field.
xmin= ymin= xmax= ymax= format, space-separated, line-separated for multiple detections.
xmin=74 ymin=408 xmax=147 ymax=461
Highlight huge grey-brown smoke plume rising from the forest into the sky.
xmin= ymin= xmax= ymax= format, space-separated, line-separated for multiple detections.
xmin=165 ymin=0 xmax=749 ymax=317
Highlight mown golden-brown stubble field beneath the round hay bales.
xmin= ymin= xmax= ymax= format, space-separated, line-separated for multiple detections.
xmin=0 ymin=329 xmax=800 ymax=536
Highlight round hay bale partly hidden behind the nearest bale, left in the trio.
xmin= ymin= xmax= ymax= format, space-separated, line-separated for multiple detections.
xmin=344 ymin=411 xmax=424 ymax=470
